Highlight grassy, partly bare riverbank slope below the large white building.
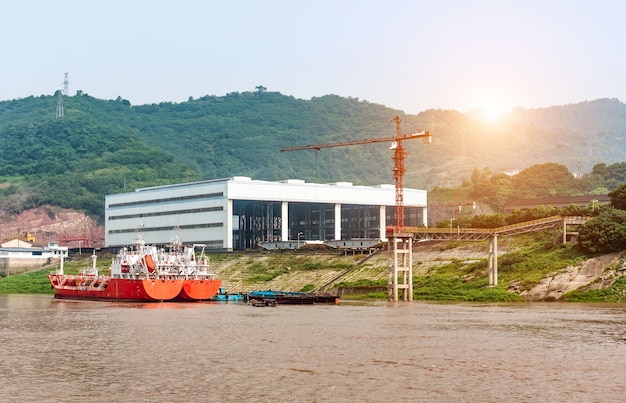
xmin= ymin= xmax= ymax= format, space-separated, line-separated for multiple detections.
xmin=0 ymin=236 xmax=626 ymax=302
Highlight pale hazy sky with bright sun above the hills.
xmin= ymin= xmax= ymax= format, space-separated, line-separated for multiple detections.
xmin=0 ymin=0 xmax=626 ymax=114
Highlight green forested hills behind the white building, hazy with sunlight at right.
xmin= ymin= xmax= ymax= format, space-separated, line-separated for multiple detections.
xmin=0 ymin=87 xmax=626 ymax=221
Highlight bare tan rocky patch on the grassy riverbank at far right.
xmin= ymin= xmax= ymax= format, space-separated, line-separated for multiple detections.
xmin=509 ymin=252 xmax=626 ymax=301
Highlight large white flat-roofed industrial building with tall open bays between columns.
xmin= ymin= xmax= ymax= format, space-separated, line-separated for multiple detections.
xmin=105 ymin=176 xmax=427 ymax=251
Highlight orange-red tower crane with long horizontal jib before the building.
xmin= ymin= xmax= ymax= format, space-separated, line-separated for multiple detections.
xmin=280 ymin=116 xmax=432 ymax=229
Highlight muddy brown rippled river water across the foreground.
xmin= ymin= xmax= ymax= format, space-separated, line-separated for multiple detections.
xmin=0 ymin=295 xmax=626 ymax=403
